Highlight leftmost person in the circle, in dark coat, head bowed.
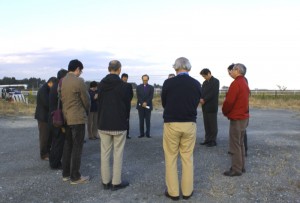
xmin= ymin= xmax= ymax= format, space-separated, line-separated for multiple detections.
xmin=34 ymin=77 xmax=56 ymax=160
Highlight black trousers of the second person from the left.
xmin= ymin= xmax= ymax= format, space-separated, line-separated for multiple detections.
xmin=49 ymin=121 xmax=65 ymax=169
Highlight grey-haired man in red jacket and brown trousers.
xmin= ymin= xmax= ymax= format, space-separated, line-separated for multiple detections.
xmin=222 ymin=63 xmax=250 ymax=176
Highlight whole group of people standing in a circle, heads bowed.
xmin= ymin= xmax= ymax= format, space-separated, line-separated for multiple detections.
xmin=35 ymin=57 xmax=250 ymax=200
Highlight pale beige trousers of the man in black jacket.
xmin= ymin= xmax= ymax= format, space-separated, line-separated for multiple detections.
xmin=99 ymin=130 xmax=127 ymax=185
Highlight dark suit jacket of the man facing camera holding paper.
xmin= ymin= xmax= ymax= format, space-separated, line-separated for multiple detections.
xmin=136 ymin=84 xmax=154 ymax=110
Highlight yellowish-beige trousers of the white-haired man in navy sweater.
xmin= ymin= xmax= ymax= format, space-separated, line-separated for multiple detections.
xmin=163 ymin=122 xmax=197 ymax=197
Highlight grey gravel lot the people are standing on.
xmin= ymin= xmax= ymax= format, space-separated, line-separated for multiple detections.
xmin=0 ymin=109 xmax=300 ymax=203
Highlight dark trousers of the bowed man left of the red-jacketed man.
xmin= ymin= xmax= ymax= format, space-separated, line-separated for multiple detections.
xmin=203 ymin=112 xmax=218 ymax=142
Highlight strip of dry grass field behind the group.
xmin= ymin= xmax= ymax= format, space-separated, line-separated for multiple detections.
xmin=0 ymin=94 xmax=300 ymax=116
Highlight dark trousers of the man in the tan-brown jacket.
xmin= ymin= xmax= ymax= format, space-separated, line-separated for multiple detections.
xmin=62 ymin=124 xmax=85 ymax=181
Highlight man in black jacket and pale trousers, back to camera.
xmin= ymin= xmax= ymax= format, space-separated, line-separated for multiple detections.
xmin=98 ymin=60 xmax=130 ymax=191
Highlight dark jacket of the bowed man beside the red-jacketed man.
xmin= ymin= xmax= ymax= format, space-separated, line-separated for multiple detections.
xmin=201 ymin=76 xmax=220 ymax=113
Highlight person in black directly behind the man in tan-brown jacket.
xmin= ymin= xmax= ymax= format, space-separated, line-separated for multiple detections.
xmin=48 ymin=69 xmax=68 ymax=169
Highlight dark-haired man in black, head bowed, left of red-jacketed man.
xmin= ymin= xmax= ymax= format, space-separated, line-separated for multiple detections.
xmin=200 ymin=68 xmax=220 ymax=147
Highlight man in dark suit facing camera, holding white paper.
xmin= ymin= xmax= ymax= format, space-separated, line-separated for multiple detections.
xmin=136 ymin=75 xmax=154 ymax=138
